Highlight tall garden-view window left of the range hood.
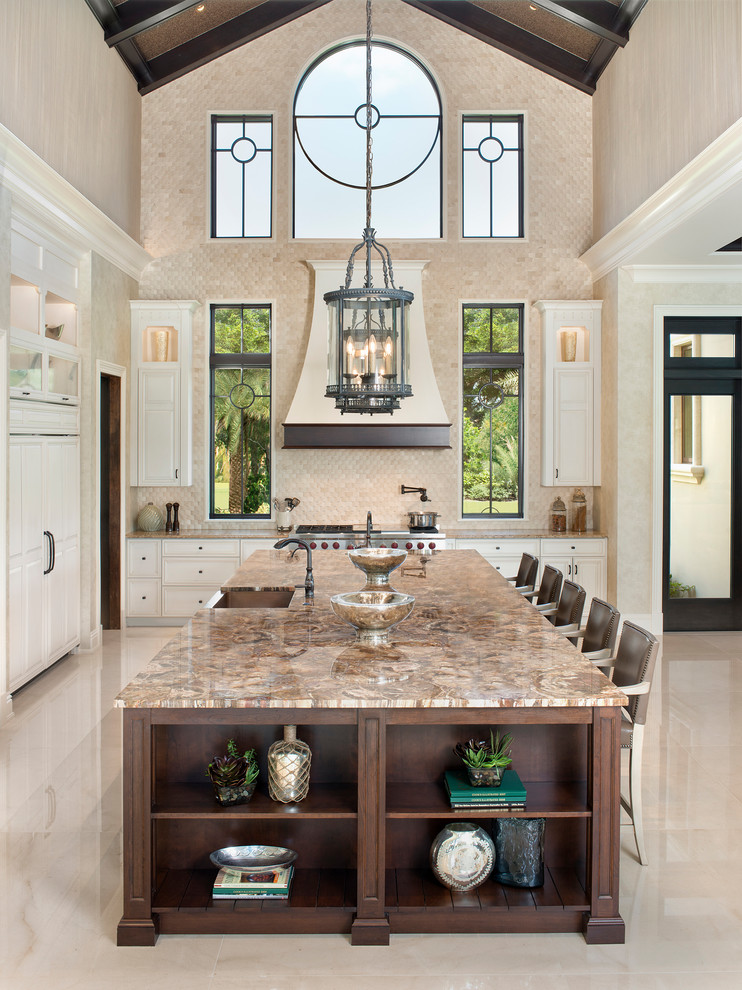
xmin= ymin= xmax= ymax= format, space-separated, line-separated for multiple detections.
xmin=209 ymin=306 xmax=271 ymax=519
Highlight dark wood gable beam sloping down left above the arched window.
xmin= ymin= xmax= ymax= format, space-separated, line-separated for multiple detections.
xmin=139 ymin=0 xmax=330 ymax=94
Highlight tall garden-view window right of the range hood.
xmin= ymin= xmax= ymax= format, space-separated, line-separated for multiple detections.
xmin=462 ymin=304 xmax=523 ymax=518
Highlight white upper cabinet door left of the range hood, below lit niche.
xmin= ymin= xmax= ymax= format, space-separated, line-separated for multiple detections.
xmin=137 ymin=369 xmax=180 ymax=486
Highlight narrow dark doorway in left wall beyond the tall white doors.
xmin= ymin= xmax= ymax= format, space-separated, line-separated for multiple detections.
xmin=98 ymin=372 xmax=121 ymax=629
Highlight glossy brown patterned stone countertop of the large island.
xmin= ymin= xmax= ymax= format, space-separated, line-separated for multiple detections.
xmin=116 ymin=550 xmax=626 ymax=708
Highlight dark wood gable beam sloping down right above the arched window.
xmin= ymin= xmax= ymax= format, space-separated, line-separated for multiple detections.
xmin=403 ymin=0 xmax=595 ymax=94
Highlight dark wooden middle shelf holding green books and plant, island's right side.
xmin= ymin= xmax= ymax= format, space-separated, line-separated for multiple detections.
xmin=386 ymin=781 xmax=592 ymax=820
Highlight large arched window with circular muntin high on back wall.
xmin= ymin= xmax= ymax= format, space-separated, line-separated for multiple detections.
xmin=294 ymin=41 xmax=442 ymax=242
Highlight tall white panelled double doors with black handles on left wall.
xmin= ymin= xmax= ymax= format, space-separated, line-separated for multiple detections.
xmin=8 ymin=436 xmax=80 ymax=691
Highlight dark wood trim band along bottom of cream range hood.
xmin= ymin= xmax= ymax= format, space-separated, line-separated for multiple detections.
xmin=283 ymin=423 xmax=451 ymax=450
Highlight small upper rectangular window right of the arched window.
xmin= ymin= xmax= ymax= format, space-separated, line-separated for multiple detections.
xmin=461 ymin=114 xmax=524 ymax=237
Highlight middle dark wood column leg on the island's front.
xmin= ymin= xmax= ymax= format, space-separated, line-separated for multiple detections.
xmin=351 ymin=708 xmax=390 ymax=945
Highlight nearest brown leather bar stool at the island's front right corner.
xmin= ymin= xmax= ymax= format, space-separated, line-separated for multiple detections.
xmin=598 ymin=621 xmax=659 ymax=866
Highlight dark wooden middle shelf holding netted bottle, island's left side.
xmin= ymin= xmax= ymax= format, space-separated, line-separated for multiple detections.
xmin=152 ymin=783 xmax=358 ymax=819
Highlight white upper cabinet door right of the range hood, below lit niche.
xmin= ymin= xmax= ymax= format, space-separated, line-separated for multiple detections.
xmin=554 ymin=368 xmax=593 ymax=485
